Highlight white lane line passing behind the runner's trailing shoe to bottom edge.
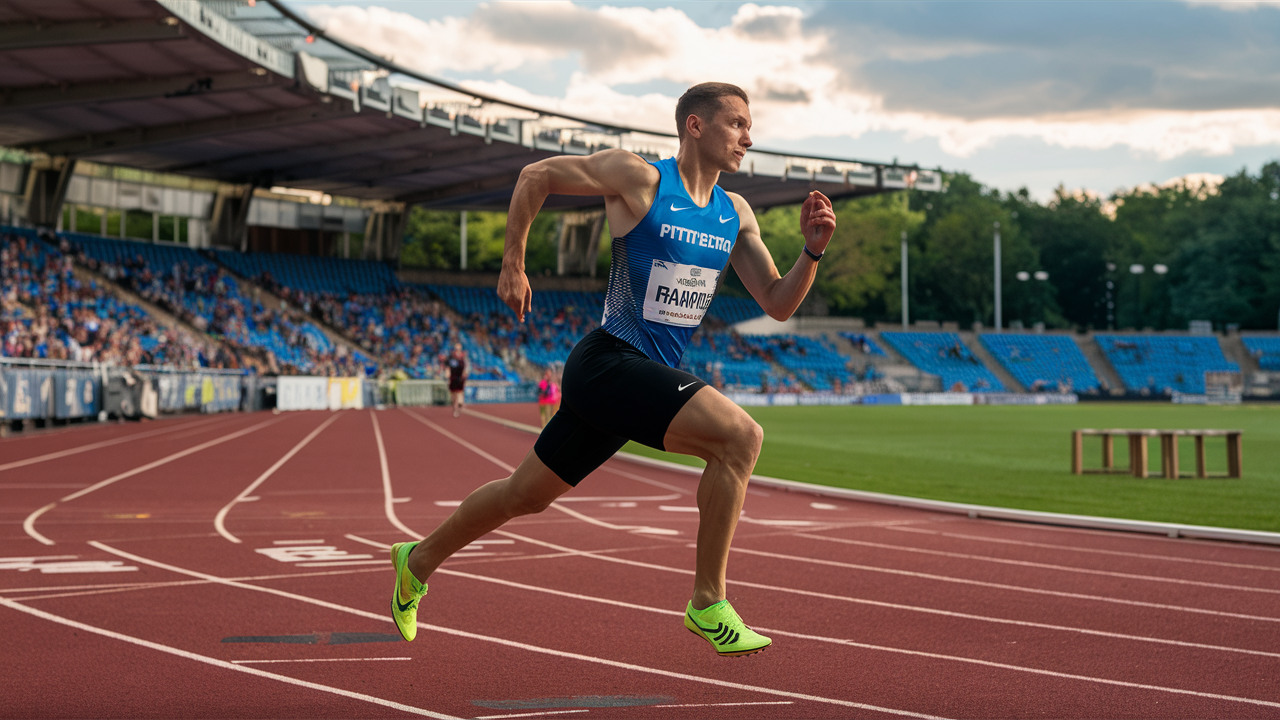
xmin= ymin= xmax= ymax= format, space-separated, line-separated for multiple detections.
xmin=85 ymin=541 xmax=942 ymax=720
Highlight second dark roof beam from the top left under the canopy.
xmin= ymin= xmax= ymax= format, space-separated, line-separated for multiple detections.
xmin=0 ymin=70 xmax=275 ymax=114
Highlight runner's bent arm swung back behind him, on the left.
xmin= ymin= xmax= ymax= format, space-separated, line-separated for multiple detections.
xmin=498 ymin=150 xmax=659 ymax=322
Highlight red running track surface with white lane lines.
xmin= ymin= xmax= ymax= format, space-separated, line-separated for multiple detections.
xmin=0 ymin=406 xmax=1280 ymax=719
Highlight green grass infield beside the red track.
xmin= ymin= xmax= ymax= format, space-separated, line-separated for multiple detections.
xmin=625 ymin=404 xmax=1280 ymax=530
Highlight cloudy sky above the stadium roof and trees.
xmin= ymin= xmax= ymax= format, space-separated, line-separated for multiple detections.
xmin=282 ymin=0 xmax=1280 ymax=199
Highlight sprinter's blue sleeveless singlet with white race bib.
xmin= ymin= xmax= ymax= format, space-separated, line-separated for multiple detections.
xmin=600 ymin=158 xmax=739 ymax=368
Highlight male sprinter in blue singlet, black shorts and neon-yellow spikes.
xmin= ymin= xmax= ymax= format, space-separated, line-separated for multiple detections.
xmin=392 ymin=83 xmax=836 ymax=656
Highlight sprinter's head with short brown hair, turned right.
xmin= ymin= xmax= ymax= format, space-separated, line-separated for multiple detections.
xmin=676 ymin=82 xmax=751 ymax=173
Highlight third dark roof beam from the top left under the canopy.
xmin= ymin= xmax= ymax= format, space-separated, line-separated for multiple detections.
xmin=24 ymin=99 xmax=352 ymax=156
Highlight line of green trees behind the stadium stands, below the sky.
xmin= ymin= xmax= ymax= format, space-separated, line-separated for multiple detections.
xmin=402 ymin=163 xmax=1280 ymax=329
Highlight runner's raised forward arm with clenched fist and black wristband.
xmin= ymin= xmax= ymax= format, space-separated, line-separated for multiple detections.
xmin=730 ymin=192 xmax=836 ymax=320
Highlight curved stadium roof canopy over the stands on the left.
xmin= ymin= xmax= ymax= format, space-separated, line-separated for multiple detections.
xmin=0 ymin=0 xmax=941 ymax=210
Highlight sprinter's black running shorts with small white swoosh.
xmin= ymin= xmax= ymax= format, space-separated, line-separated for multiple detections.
xmin=534 ymin=329 xmax=707 ymax=486
